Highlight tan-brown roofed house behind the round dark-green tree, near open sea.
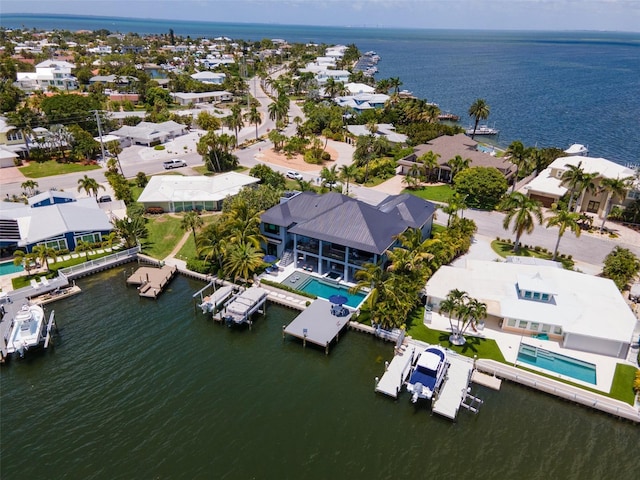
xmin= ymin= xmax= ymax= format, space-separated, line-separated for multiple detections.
xmin=398 ymin=133 xmax=516 ymax=182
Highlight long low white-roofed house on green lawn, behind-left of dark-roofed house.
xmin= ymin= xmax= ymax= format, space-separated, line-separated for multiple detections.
xmin=138 ymin=172 xmax=260 ymax=212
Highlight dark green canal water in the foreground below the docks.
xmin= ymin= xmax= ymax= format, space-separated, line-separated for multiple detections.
xmin=0 ymin=264 xmax=640 ymax=480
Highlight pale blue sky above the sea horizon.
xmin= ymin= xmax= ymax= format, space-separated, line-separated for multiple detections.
xmin=0 ymin=0 xmax=640 ymax=32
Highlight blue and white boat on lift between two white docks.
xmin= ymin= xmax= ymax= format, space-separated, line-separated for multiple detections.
xmin=407 ymin=345 xmax=449 ymax=403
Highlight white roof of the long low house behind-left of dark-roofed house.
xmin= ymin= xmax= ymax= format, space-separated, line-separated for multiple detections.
xmin=138 ymin=172 xmax=260 ymax=203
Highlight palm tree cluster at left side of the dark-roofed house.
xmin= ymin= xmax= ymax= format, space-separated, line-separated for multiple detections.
xmin=194 ymin=197 xmax=264 ymax=282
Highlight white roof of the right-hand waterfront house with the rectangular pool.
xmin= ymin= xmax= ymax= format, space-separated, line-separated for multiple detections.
xmin=427 ymin=260 xmax=636 ymax=343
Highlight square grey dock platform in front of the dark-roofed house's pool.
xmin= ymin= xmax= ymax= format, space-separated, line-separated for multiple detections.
xmin=282 ymin=299 xmax=353 ymax=354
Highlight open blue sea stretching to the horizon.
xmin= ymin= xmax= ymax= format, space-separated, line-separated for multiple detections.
xmin=1 ymin=15 xmax=640 ymax=164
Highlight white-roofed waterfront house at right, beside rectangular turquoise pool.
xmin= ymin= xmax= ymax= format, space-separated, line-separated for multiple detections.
xmin=426 ymin=260 xmax=636 ymax=358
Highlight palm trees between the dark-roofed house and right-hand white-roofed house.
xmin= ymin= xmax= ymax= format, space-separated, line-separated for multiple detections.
xmin=351 ymin=219 xmax=476 ymax=328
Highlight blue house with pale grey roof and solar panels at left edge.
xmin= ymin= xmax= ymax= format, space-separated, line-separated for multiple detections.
xmin=0 ymin=191 xmax=113 ymax=252
